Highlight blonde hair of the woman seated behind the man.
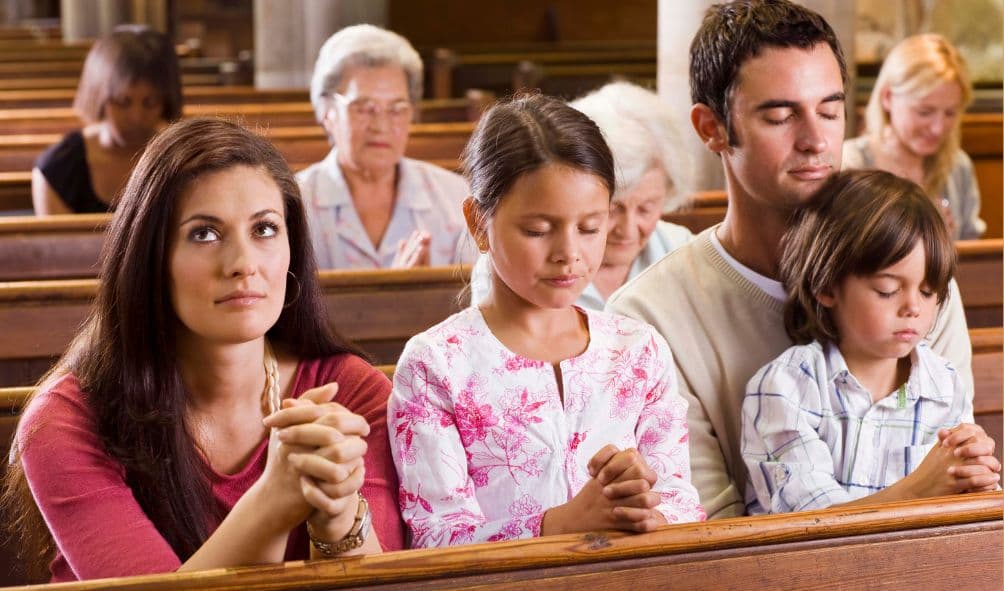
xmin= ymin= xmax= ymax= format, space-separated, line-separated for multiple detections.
xmin=864 ymin=33 xmax=973 ymax=195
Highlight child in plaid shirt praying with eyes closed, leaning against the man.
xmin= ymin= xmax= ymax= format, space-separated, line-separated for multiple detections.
xmin=742 ymin=171 xmax=1001 ymax=514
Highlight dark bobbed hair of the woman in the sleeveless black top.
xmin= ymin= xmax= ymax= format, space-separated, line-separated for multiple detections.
xmin=73 ymin=25 xmax=182 ymax=123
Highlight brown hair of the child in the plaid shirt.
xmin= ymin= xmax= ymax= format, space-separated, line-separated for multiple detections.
xmin=780 ymin=171 xmax=956 ymax=344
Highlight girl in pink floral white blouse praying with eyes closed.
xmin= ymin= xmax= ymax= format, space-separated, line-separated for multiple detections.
xmin=388 ymin=95 xmax=705 ymax=547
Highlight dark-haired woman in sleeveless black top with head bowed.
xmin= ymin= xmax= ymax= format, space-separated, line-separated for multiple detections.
xmin=31 ymin=25 xmax=182 ymax=216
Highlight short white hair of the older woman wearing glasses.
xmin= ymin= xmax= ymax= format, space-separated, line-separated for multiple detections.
xmin=310 ymin=25 xmax=422 ymax=121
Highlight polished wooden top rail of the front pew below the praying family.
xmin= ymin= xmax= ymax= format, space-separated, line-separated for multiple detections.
xmin=11 ymin=493 xmax=1004 ymax=591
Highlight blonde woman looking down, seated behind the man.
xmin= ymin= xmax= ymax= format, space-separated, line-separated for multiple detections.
xmin=843 ymin=33 xmax=987 ymax=240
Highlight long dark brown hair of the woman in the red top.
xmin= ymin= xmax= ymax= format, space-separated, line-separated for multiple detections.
xmin=4 ymin=118 xmax=365 ymax=572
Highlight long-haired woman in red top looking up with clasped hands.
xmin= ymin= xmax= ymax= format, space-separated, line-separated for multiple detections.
xmin=6 ymin=119 xmax=403 ymax=581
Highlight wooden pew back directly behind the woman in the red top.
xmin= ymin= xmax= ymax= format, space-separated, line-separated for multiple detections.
xmin=0 ymin=266 xmax=470 ymax=386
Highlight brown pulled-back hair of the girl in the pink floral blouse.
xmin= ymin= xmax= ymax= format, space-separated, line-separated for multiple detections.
xmin=462 ymin=94 xmax=615 ymax=224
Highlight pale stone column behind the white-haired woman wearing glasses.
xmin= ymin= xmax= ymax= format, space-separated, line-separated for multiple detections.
xmin=254 ymin=0 xmax=387 ymax=88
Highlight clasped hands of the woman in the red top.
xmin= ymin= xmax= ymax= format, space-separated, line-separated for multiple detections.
xmin=262 ymin=383 xmax=369 ymax=542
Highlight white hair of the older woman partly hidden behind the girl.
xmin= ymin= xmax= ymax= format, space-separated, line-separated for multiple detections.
xmin=569 ymin=82 xmax=692 ymax=212
